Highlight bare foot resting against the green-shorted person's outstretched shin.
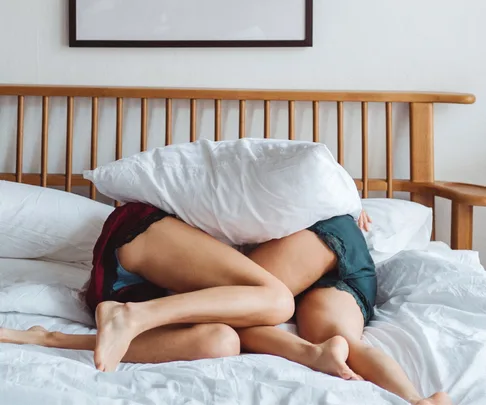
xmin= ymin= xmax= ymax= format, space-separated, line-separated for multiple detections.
xmin=312 ymin=336 xmax=363 ymax=381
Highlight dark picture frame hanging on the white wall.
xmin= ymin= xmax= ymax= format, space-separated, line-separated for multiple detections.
xmin=69 ymin=0 xmax=314 ymax=48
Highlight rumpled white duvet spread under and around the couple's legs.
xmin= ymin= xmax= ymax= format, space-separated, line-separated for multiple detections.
xmin=0 ymin=245 xmax=486 ymax=405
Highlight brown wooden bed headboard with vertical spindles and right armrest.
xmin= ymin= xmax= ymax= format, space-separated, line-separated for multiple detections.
xmin=0 ymin=85 xmax=486 ymax=249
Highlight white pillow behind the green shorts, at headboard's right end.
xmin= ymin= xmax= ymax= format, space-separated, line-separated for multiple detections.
xmin=362 ymin=198 xmax=432 ymax=261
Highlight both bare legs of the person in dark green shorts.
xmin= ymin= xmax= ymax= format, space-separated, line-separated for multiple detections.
xmin=228 ymin=231 xmax=452 ymax=405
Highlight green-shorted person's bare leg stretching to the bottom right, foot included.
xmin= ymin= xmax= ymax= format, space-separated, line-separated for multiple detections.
xmin=297 ymin=288 xmax=452 ymax=405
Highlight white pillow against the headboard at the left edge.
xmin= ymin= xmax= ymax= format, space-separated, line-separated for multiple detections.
xmin=0 ymin=181 xmax=113 ymax=263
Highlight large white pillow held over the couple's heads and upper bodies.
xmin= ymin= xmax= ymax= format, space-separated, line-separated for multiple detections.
xmin=84 ymin=139 xmax=361 ymax=245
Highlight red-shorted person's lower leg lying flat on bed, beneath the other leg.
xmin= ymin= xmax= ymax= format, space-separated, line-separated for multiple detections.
xmin=0 ymin=324 xmax=240 ymax=363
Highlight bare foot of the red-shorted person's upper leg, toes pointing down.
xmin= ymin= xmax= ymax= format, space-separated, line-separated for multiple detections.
xmin=94 ymin=301 xmax=138 ymax=371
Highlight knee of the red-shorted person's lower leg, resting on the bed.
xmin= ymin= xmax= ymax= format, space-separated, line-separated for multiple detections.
xmin=195 ymin=323 xmax=240 ymax=359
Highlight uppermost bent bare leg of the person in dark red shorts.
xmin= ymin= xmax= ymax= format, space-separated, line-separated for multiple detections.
xmin=95 ymin=218 xmax=294 ymax=371
